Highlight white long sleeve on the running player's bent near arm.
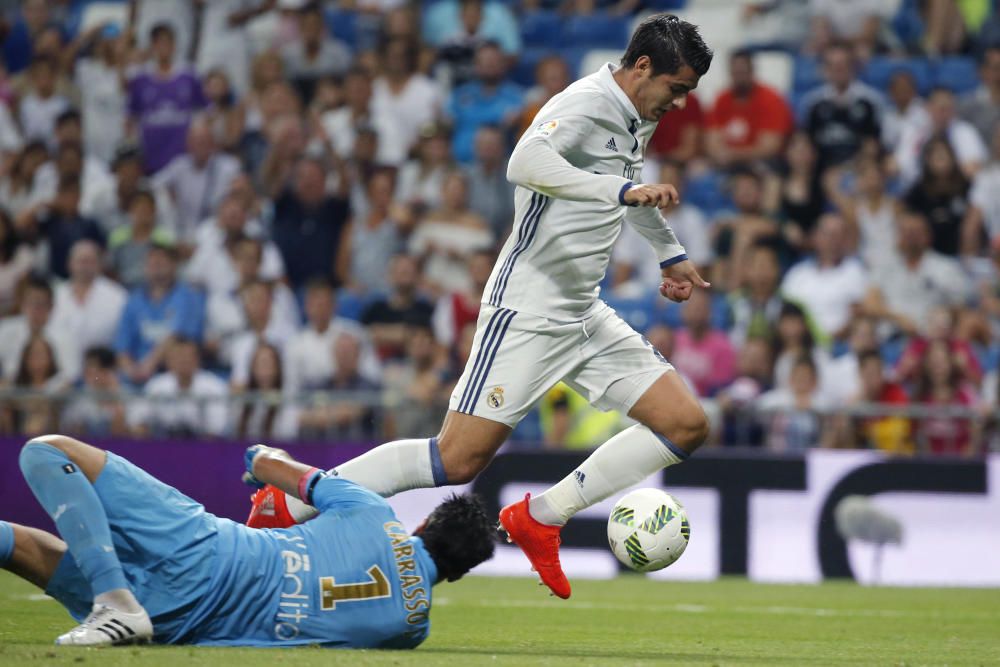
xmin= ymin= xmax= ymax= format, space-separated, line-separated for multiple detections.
xmin=507 ymin=116 xmax=632 ymax=205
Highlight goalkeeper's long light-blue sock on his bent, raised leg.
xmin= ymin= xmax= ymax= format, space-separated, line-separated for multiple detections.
xmin=18 ymin=440 xmax=128 ymax=596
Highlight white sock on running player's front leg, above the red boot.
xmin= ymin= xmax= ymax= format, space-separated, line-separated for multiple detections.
xmin=528 ymin=424 xmax=687 ymax=526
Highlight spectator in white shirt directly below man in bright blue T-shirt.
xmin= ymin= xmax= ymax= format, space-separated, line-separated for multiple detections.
xmin=128 ymin=337 xmax=229 ymax=437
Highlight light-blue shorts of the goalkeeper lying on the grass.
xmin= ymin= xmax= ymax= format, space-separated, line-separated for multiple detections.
xmin=45 ymin=452 xmax=220 ymax=643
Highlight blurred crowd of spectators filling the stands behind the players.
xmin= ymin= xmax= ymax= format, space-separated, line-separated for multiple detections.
xmin=0 ymin=0 xmax=1000 ymax=455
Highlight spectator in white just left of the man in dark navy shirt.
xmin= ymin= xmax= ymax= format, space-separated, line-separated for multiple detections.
xmin=185 ymin=193 xmax=285 ymax=295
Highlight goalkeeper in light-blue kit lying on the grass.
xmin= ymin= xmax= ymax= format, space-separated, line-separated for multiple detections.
xmin=0 ymin=435 xmax=495 ymax=648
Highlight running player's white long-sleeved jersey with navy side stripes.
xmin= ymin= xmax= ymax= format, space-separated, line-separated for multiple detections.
xmin=482 ymin=63 xmax=686 ymax=321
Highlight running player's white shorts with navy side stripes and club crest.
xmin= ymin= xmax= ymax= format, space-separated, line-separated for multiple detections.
xmin=448 ymin=301 xmax=674 ymax=426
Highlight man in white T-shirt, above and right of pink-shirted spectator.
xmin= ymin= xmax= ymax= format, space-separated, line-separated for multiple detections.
xmin=781 ymin=213 xmax=868 ymax=338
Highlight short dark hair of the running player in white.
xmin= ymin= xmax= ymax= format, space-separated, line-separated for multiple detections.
xmin=622 ymin=14 xmax=712 ymax=76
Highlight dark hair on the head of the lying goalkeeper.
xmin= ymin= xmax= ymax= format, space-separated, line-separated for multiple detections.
xmin=417 ymin=494 xmax=496 ymax=581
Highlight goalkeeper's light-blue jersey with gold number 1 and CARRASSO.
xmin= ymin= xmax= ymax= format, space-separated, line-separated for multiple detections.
xmin=188 ymin=475 xmax=437 ymax=648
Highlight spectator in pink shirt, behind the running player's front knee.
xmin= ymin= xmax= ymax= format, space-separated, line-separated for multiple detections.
xmin=671 ymin=290 xmax=736 ymax=396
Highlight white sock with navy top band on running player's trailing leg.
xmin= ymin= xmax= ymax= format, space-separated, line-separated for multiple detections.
xmin=334 ymin=438 xmax=448 ymax=497
